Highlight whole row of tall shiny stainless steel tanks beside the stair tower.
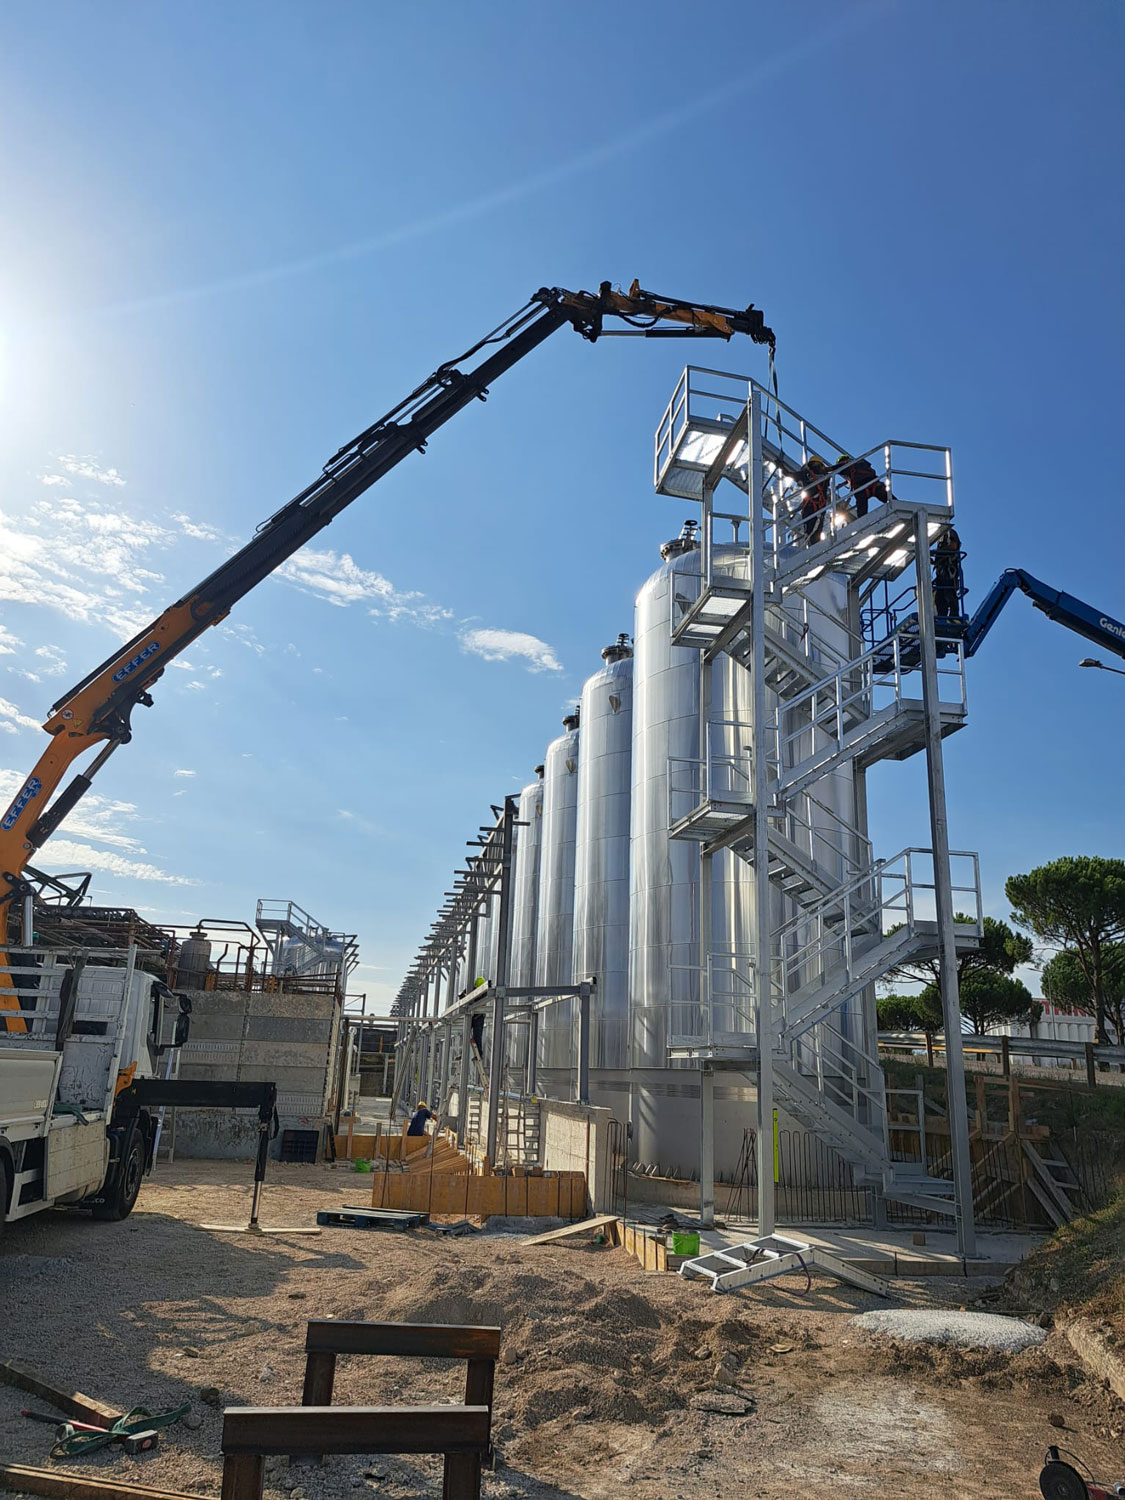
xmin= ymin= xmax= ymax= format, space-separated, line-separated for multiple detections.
xmin=462 ymin=536 xmax=854 ymax=1175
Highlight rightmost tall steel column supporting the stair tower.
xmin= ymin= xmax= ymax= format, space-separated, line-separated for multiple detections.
xmin=914 ymin=510 xmax=977 ymax=1256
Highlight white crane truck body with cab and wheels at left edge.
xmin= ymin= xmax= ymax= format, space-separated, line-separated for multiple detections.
xmin=0 ymin=947 xmax=191 ymax=1227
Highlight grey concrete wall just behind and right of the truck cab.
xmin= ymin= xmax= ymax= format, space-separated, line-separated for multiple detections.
xmin=176 ymin=990 xmax=341 ymax=1158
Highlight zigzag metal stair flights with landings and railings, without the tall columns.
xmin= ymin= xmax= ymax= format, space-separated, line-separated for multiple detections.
xmin=656 ymin=369 xmax=981 ymax=1212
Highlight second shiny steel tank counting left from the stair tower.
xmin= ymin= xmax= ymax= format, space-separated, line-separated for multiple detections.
xmin=573 ymin=635 xmax=633 ymax=1112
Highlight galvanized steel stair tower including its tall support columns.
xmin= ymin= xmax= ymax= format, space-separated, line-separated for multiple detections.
xmin=654 ymin=366 xmax=983 ymax=1256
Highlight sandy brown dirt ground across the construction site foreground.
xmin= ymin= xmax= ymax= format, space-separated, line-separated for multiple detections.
xmin=0 ymin=1163 xmax=1125 ymax=1500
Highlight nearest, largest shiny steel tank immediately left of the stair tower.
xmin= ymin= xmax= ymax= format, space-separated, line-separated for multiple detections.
xmin=630 ymin=536 xmax=755 ymax=1176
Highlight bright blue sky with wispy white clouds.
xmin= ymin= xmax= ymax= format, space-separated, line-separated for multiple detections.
xmin=0 ymin=0 xmax=1125 ymax=1005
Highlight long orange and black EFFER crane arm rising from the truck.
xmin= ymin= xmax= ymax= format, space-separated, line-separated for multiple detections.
xmin=0 ymin=282 xmax=774 ymax=1031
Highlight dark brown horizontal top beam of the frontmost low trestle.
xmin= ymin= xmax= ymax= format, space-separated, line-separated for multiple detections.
xmin=221 ymin=1406 xmax=491 ymax=1458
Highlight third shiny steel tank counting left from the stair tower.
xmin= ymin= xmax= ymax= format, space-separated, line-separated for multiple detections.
xmin=536 ymin=711 xmax=581 ymax=1098
